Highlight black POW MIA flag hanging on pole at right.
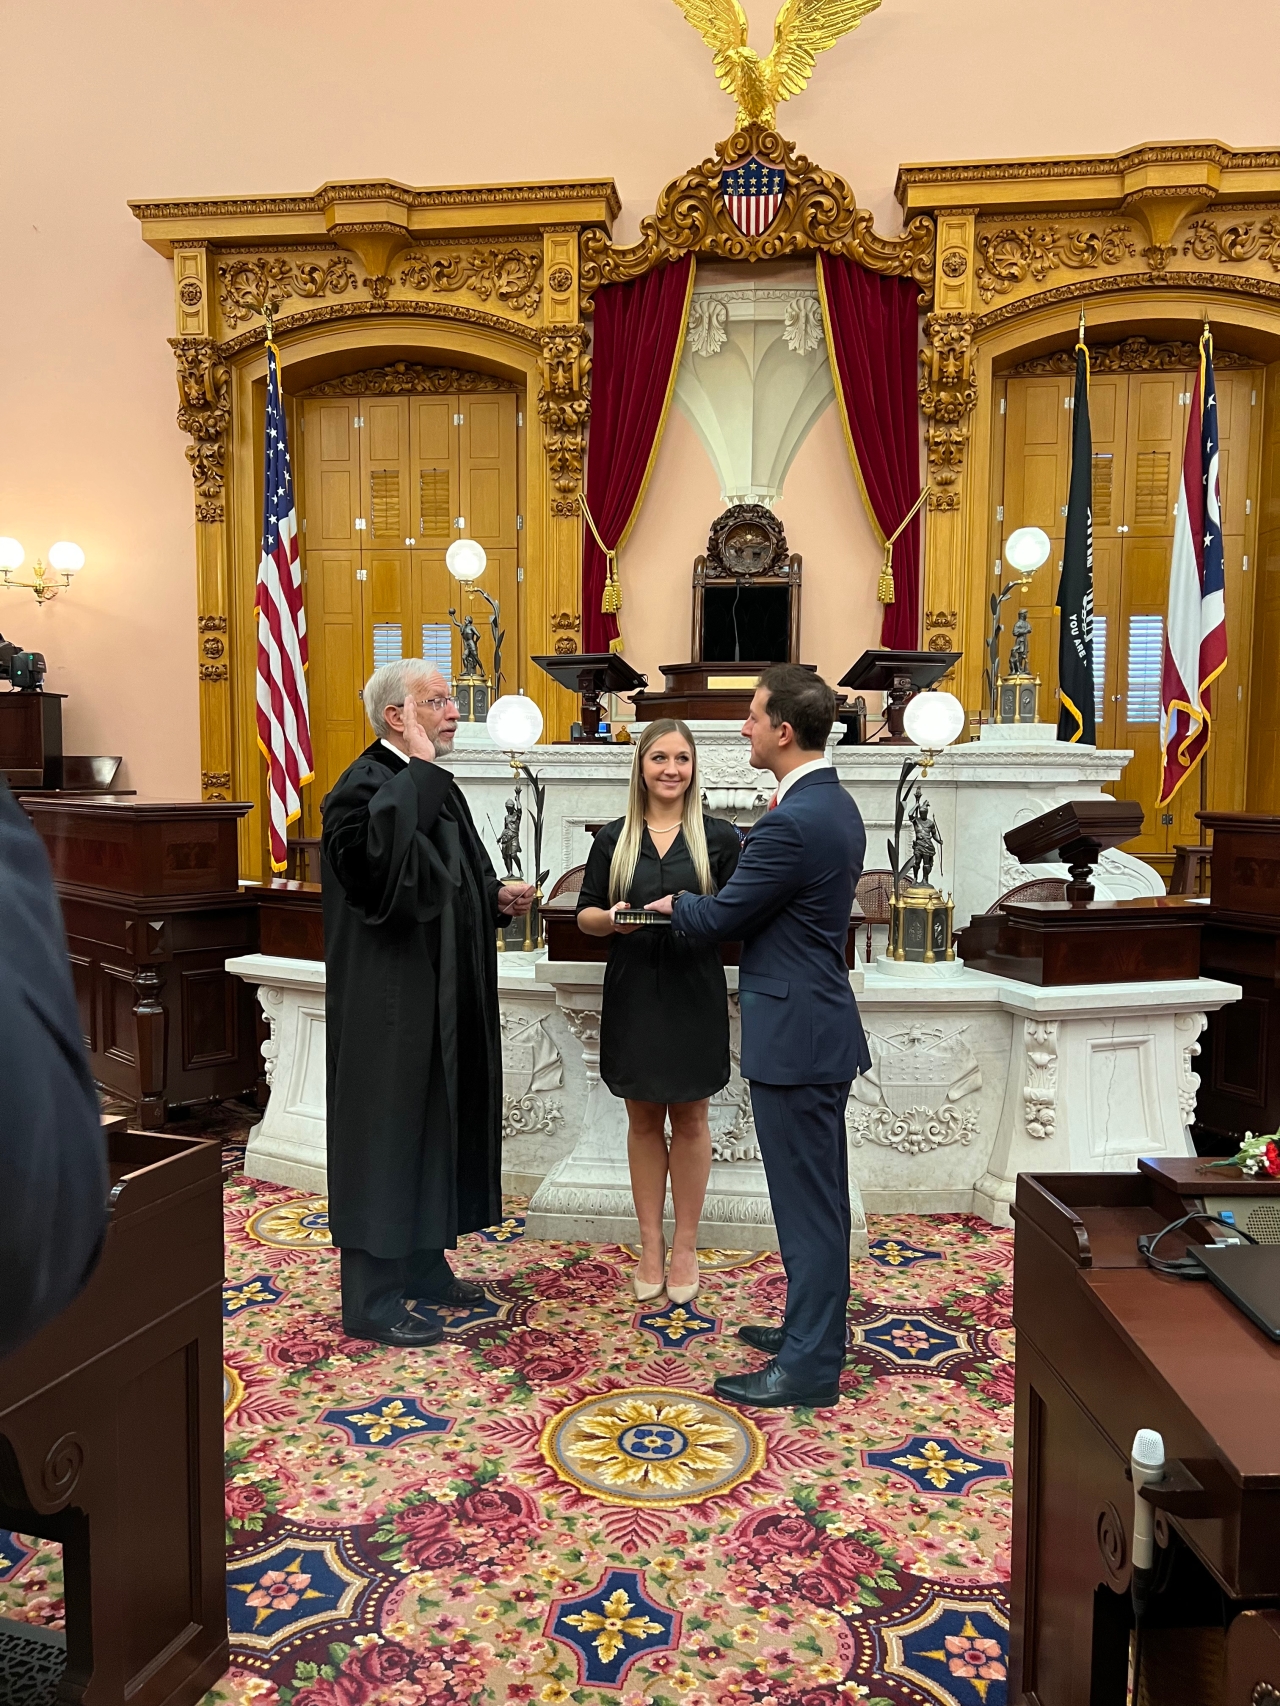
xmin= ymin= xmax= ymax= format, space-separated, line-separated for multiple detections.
xmin=1058 ymin=338 xmax=1096 ymax=746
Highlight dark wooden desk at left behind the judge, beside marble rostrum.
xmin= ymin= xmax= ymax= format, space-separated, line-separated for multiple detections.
xmin=22 ymin=795 xmax=259 ymax=1128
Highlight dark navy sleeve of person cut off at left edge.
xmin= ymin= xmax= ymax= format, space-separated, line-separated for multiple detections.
xmin=0 ymin=780 xmax=108 ymax=1356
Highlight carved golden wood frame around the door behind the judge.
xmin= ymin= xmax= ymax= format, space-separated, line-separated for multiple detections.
xmin=130 ymin=179 xmax=620 ymax=877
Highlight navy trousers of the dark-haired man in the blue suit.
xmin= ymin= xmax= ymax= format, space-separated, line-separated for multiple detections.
xmin=751 ymin=1080 xmax=850 ymax=1387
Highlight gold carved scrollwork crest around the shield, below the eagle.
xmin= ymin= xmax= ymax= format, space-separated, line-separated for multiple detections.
xmin=580 ymin=125 xmax=934 ymax=305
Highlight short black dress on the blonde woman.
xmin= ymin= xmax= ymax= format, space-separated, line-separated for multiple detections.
xmin=579 ymin=817 xmax=741 ymax=1102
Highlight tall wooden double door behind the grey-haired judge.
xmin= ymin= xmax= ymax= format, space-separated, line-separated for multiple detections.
xmin=295 ymin=391 xmax=521 ymax=834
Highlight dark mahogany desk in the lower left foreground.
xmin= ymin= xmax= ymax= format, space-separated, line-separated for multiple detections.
xmin=0 ymin=1131 xmax=229 ymax=1706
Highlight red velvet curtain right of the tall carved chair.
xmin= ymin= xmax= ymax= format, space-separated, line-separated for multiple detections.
xmin=817 ymin=254 xmax=922 ymax=652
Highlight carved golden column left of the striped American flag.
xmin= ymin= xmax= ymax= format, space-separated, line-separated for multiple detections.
xmin=169 ymin=242 xmax=232 ymax=800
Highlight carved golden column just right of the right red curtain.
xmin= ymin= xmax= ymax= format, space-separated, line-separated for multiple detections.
xmin=920 ymin=208 xmax=980 ymax=703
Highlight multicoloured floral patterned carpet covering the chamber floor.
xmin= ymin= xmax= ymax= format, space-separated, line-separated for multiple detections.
xmin=0 ymin=1177 xmax=1014 ymax=1706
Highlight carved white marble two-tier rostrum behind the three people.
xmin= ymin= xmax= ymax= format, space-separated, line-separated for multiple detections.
xmin=227 ymin=723 xmax=1239 ymax=1254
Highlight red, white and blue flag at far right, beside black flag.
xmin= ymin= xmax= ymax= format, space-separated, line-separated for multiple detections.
xmin=1157 ymin=328 xmax=1227 ymax=805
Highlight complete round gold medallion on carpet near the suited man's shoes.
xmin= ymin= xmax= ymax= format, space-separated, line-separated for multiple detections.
xmin=541 ymin=1387 xmax=765 ymax=1510
